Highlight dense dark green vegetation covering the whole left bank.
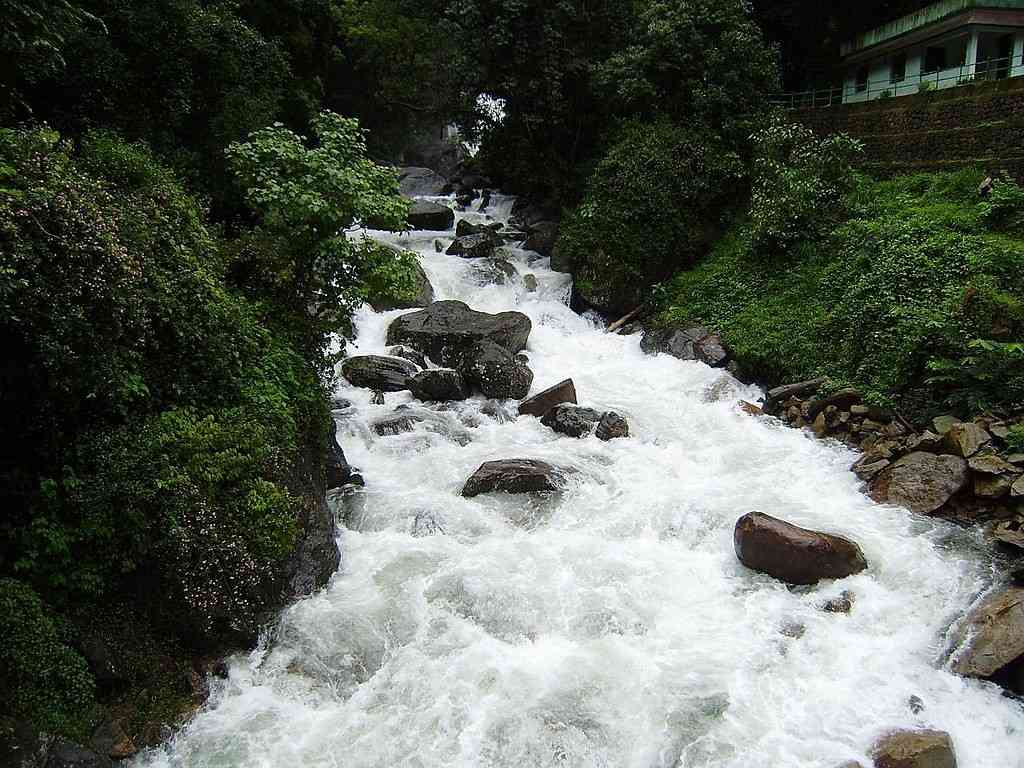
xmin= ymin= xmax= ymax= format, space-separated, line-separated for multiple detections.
xmin=0 ymin=0 xmax=423 ymax=739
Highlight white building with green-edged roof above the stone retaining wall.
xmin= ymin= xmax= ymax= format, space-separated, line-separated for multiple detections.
xmin=829 ymin=0 xmax=1024 ymax=103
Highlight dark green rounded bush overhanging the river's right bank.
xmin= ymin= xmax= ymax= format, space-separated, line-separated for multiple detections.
xmin=557 ymin=119 xmax=742 ymax=311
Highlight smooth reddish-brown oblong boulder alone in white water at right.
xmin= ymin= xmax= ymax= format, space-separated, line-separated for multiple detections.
xmin=732 ymin=512 xmax=867 ymax=584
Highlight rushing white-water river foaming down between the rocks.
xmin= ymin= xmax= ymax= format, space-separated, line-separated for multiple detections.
xmin=137 ymin=198 xmax=1024 ymax=768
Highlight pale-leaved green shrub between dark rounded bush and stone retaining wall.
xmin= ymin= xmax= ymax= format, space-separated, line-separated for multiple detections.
xmin=750 ymin=123 xmax=863 ymax=253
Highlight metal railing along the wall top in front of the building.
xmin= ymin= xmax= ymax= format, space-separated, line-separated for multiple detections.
xmin=770 ymin=53 xmax=1024 ymax=110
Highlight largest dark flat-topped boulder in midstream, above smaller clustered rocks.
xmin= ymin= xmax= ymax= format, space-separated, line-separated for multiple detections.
xmin=387 ymin=301 xmax=532 ymax=368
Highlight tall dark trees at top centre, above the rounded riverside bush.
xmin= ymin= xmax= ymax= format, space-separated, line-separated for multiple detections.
xmin=449 ymin=0 xmax=777 ymax=204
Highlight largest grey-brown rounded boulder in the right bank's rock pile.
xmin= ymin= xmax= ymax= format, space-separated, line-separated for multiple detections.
xmin=870 ymin=451 xmax=971 ymax=515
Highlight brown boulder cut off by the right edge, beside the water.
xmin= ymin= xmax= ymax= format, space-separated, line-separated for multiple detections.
xmin=953 ymin=587 xmax=1024 ymax=678
